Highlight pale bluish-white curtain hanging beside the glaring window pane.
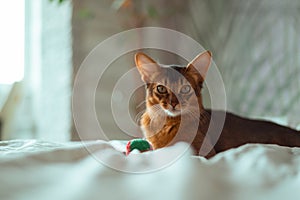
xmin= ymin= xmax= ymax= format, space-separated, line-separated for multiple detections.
xmin=2 ymin=0 xmax=72 ymax=141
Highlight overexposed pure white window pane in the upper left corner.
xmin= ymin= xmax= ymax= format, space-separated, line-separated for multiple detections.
xmin=0 ymin=0 xmax=25 ymax=84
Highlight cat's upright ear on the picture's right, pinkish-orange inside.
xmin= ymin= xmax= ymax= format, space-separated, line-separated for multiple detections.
xmin=187 ymin=51 xmax=212 ymax=81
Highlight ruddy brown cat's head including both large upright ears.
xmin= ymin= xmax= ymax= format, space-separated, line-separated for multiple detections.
xmin=135 ymin=51 xmax=211 ymax=117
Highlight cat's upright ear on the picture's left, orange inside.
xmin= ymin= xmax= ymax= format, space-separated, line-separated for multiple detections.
xmin=135 ymin=52 xmax=160 ymax=83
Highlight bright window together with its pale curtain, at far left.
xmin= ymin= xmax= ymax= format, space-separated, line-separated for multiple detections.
xmin=0 ymin=0 xmax=72 ymax=141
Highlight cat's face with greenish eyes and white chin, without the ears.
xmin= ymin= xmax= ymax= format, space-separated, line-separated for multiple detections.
xmin=141 ymin=67 xmax=201 ymax=117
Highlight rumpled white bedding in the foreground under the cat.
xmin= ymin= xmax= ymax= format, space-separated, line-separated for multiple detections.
xmin=0 ymin=140 xmax=300 ymax=200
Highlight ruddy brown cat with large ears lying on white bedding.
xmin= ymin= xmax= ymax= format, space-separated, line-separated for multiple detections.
xmin=135 ymin=51 xmax=300 ymax=158
